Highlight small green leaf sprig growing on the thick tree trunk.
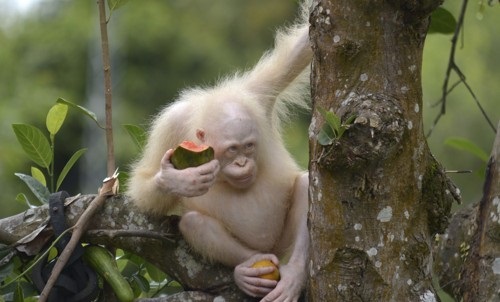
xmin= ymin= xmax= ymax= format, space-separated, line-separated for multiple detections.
xmin=318 ymin=107 xmax=356 ymax=146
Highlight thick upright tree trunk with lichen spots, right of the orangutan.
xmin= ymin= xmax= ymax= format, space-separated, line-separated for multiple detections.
xmin=308 ymin=0 xmax=458 ymax=301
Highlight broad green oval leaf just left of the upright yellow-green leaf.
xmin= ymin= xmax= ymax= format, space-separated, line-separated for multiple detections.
xmin=12 ymin=124 xmax=52 ymax=169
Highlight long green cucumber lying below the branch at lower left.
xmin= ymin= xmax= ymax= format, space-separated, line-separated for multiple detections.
xmin=83 ymin=245 xmax=134 ymax=302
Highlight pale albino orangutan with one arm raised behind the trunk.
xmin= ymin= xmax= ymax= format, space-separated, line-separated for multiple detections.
xmin=127 ymin=3 xmax=312 ymax=301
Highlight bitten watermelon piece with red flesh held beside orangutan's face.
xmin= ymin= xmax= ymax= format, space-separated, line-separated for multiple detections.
xmin=170 ymin=141 xmax=214 ymax=170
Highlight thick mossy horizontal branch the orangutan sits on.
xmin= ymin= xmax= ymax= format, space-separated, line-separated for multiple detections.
xmin=0 ymin=195 xmax=252 ymax=301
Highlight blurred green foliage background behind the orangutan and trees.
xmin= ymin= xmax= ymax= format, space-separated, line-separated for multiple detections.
xmin=0 ymin=0 xmax=500 ymax=218
